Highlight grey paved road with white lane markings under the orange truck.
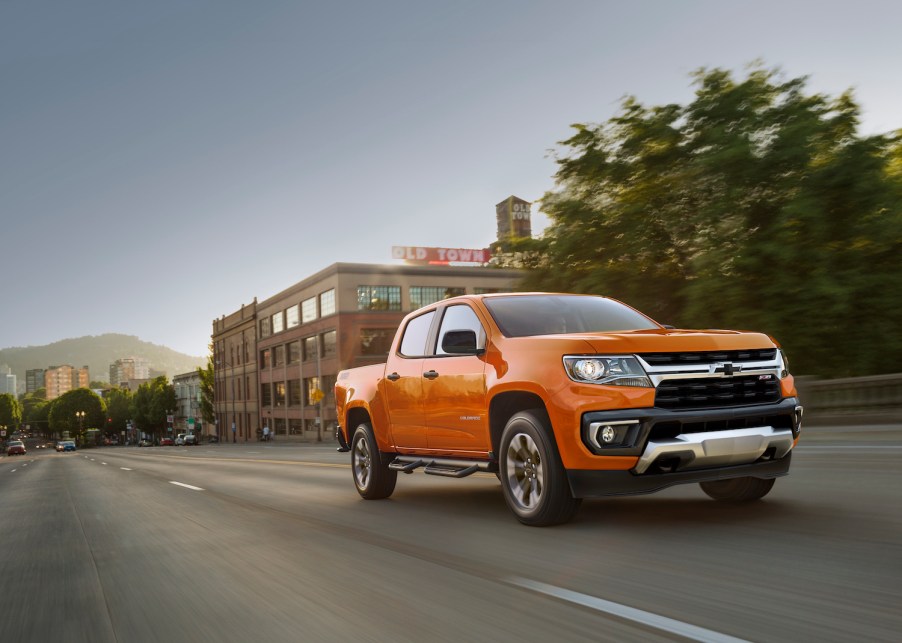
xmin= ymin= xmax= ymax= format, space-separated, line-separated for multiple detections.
xmin=0 ymin=427 xmax=902 ymax=643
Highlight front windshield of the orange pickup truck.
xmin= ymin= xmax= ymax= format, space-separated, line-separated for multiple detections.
xmin=484 ymin=295 xmax=660 ymax=337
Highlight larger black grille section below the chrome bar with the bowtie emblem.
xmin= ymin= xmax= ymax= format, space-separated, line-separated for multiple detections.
xmin=655 ymin=375 xmax=780 ymax=409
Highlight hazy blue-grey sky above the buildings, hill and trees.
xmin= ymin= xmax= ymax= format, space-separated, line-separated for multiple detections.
xmin=0 ymin=0 xmax=902 ymax=355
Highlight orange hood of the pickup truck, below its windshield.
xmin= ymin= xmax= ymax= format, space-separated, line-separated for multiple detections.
xmin=521 ymin=329 xmax=776 ymax=354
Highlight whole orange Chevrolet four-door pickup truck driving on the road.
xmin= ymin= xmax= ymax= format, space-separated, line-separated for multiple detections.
xmin=335 ymin=293 xmax=802 ymax=526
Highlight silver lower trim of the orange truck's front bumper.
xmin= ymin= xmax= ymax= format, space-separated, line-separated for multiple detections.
xmin=632 ymin=426 xmax=793 ymax=474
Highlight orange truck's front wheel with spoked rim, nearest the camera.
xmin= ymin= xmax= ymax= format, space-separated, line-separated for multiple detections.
xmin=499 ymin=410 xmax=581 ymax=527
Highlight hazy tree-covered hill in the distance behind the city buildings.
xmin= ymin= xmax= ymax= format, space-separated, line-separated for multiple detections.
xmin=0 ymin=333 xmax=206 ymax=391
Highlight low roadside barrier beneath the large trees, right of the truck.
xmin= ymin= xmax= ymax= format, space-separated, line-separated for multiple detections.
xmin=796 ymin=373 xmax=902 ymax=422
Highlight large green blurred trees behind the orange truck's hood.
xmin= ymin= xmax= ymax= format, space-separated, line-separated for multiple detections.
xmin=512 ymin=64 xmax=902 ymax=377
